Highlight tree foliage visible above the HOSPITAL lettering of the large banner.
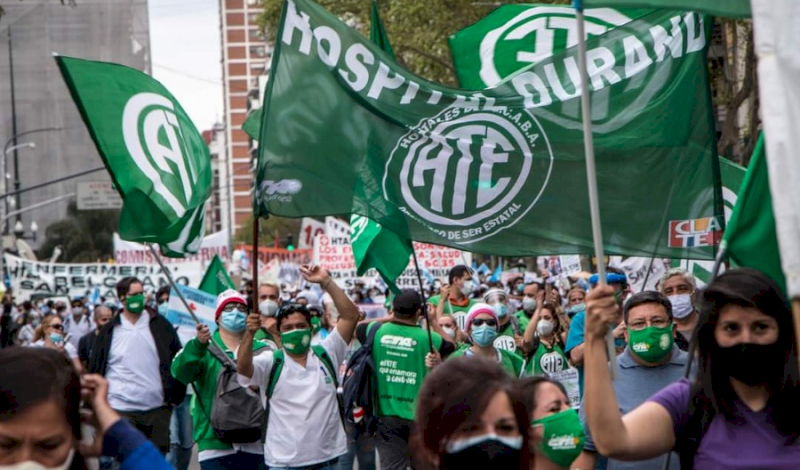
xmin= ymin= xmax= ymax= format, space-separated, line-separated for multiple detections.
xmin=260 ymin=0 xmax=569 ymax=86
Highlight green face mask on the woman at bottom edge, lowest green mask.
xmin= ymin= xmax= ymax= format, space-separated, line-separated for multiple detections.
xmin=533 ymin=409 xmax=586 ymax=467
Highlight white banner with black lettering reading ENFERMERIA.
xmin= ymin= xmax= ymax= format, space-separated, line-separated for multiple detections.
xmin=5 ymin=254 xmax=204 ymax=301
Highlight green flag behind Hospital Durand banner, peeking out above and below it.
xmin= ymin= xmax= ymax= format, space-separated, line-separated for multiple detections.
xmin=350 ymin=0 xmax=414 ymax=294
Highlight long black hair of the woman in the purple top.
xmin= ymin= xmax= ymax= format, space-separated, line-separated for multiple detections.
xmin=693 ymin=268 xmax=800 ymax=442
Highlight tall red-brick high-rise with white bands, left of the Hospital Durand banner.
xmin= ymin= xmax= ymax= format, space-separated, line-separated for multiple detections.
xmin=220 ymin=0 xmax=272 ymax=235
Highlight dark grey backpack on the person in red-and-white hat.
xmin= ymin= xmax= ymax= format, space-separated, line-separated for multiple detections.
xmin=192 ymin=347 xmax=266 ymax=444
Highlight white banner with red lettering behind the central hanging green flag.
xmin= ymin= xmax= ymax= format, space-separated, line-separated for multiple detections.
xmin=314 ymin=235 xmax=472 ymax=289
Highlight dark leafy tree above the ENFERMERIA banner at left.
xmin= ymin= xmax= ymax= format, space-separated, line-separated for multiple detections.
xmin=37 ymin=202 xmax=120 ymax=263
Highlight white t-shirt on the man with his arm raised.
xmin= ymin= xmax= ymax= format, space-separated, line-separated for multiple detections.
xmin=238 ymin=329 xmax=347 ymax=468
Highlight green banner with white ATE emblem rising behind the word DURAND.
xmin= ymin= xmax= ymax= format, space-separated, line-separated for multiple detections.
xmin=450 ymin=4 xmax=652 ymax=90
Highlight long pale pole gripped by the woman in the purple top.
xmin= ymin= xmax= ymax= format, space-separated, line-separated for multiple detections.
xmin=573 ymin=0 xmax=618 ymax=380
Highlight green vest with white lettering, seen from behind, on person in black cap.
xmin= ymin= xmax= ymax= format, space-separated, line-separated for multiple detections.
xmin=367 ymin=323 xmax=442 ymax=421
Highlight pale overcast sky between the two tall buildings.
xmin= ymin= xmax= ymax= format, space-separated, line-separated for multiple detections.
xmin=148 ymin=0 xmax=224 ymax=132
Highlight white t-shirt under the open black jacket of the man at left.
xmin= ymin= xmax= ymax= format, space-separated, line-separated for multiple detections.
xmin=106 ymin=312 xmax=164 ymax=411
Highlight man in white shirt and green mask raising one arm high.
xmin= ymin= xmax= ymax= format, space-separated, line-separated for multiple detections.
xmin=237 ymin=266 xmax=358 ymax=470
